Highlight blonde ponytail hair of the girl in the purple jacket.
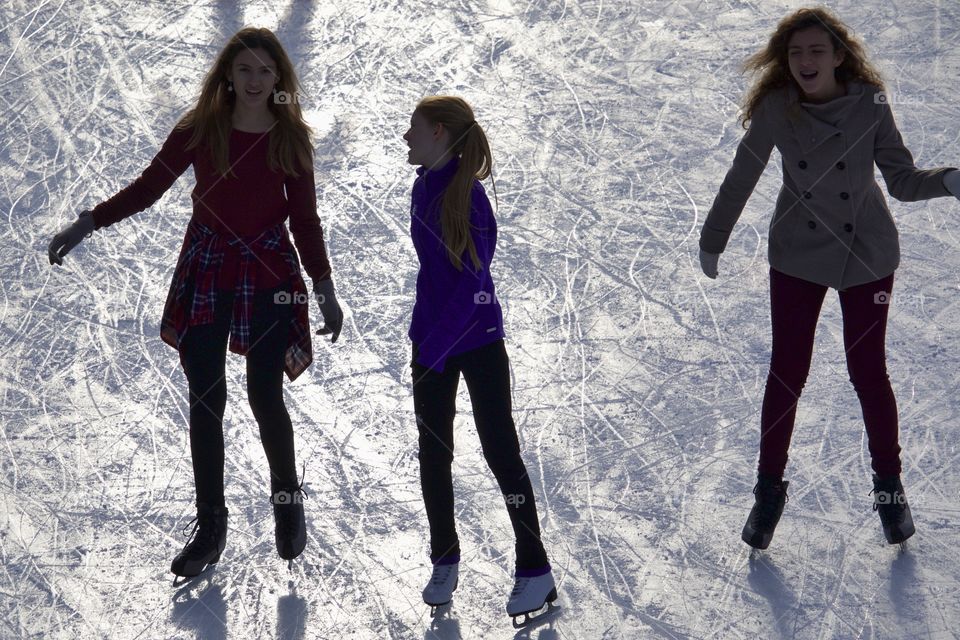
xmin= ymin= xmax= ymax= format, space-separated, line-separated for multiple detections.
xmin=414 ymin=96 xmax=497 ymax=271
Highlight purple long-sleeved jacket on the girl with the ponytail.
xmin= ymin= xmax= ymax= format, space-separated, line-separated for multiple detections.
xmin=409 ymin=157 xmax=504 ymax=371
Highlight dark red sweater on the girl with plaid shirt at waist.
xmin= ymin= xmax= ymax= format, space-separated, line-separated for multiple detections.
xmin=93 ymin=129 xmax=330 ymax=289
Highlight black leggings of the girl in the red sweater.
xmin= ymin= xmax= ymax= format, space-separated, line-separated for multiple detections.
xmin=180 ymin=286 xmax=297 ymax=506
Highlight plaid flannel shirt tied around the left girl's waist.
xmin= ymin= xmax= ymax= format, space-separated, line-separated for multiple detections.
xmin=160 ymin=220 xmax=313 ymax=380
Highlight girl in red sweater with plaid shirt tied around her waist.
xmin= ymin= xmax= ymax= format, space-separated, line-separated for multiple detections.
xmin=48 ymin=28 xmax=343 ymax=576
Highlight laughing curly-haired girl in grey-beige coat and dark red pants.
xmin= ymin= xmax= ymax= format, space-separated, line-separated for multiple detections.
xmin=700 ymin=9 xmax=960 ymax=549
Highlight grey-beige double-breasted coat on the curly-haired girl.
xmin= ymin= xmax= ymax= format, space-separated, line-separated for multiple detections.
xmin=700 ymin=82 xmax=952 ymax=290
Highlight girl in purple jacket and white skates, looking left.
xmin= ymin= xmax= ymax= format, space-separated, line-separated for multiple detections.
xmin=403 ymin=96 xmax=557 ymax=616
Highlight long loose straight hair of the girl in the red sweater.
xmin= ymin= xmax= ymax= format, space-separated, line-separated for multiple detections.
xmin=176 ymin=27 xmax=313 ymax=177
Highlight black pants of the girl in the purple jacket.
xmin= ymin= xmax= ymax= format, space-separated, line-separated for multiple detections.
xmin=411 ymin=340 xmax=547 ymax=570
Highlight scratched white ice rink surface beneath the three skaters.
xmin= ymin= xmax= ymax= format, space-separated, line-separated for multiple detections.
xmin=0 ymin=0 xmax=960 ymax=640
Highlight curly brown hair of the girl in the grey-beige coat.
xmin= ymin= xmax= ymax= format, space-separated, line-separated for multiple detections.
xmin=740 ymin=7 xmax=883 ymax=128
